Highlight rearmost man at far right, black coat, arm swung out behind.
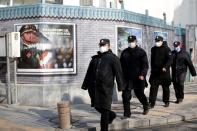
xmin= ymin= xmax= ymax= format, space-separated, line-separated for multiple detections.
xmin=172 ymin=41 xmax=196 ymax=104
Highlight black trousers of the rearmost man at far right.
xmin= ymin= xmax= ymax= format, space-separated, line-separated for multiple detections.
xmin=173 ymin=82 xmax=184 ymax=100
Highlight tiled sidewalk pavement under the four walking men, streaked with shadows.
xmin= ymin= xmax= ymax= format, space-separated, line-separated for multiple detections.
xmin=0 ymin=84 xmax=197 ymax=131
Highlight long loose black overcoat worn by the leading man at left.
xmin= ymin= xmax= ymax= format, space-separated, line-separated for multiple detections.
xmin=82 ymin=50 xmax=124 ymax=110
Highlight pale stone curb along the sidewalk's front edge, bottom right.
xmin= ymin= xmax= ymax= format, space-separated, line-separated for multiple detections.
xmin=65 ymin=112 xmax=197 ymax=131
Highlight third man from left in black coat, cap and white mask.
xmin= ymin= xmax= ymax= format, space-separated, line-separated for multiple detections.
xmin=149 ymin=36 xmax=172 ymax=108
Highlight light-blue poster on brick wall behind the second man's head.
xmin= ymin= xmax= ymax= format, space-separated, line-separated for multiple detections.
xmin=117 ymin=27 xmax=142 ymax=56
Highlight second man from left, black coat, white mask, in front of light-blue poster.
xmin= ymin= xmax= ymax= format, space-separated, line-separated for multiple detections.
xmin=120 ymin=35 xmax=149 ymax=117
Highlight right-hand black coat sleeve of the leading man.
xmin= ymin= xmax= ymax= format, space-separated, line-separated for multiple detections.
xmin=112 ymin=56 xmax=125 ymax=91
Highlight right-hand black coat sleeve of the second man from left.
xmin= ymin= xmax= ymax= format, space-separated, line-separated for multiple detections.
xmin=140 ymin=51 xmax=149 ymax=77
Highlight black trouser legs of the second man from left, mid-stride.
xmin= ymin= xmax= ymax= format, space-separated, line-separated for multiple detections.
xmin=122 ymin=88 xmax=148 ymax=117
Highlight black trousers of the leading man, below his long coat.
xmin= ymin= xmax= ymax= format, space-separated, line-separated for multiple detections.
xmin=95 ymin=107 xmax=115 ymax=131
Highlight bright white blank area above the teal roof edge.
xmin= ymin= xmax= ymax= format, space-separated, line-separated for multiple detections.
xmin=124 ymin=0 xmax=183 ymax=23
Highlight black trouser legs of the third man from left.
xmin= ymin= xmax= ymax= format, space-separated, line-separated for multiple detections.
xmin=149 ymin=83 xmax=170 ymax=105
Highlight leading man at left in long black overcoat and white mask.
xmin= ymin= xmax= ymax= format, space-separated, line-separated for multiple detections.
xmin=82 ymin=39 xmax=124 ymax=131
